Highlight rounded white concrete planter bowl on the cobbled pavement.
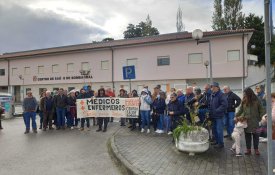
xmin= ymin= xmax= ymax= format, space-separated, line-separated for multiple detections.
xmin=175 ymin=128 xmax=209 ymax=155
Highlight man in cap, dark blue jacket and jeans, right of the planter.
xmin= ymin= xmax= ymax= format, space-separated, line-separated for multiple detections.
xmin=209 ymin=82 xmax=228 ymax=148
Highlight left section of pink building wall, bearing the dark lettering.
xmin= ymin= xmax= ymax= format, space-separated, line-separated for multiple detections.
xmin=10 ymin=50 xmax=112 ymax=85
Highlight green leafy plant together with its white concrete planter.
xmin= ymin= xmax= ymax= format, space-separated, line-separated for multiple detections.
xmin=173 ymin=103 xmax=209 ymax=155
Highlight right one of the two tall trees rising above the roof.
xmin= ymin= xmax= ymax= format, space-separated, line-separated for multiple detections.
xmin=224 ymin=0 xmax=244 ymax=30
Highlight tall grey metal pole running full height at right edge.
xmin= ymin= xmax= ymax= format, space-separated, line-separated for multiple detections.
xmin=264 ymin=0 xmax=273 ymax=175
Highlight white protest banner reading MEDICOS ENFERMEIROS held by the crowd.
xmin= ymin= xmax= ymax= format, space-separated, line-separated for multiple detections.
xmin=76 ymin=98 xmax=139 ymax=118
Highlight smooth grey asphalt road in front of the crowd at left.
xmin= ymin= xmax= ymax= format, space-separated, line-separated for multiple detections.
xmin=0 ymin=118 xmax=120 ymax=175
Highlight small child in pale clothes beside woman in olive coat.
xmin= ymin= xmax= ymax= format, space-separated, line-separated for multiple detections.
xmin=230 ymin=117 xmax=247 ymax=157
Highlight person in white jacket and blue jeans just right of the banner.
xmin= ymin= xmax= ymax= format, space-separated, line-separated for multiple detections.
xmin=140 ymin=88 xmax=153 ymax=133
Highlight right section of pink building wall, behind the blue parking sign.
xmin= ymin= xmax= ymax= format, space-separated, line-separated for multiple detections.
xmin=114 ymin=36 xmax=247 ymax=81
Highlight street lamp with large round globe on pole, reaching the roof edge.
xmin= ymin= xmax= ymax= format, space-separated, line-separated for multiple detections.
xmin=192 ymin=29 xmax=213 ymax=83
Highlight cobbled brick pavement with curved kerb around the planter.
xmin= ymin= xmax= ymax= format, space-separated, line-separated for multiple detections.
xmin=113 ymin=128 xmax=275 ymax=175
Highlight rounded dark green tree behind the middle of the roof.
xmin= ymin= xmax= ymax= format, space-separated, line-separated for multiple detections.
xmin=123 ymin=15 xmax=159 ymax=38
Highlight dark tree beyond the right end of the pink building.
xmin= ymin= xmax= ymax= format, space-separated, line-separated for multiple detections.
xmin=244 ymin=13 xmax=265 ymax=65
